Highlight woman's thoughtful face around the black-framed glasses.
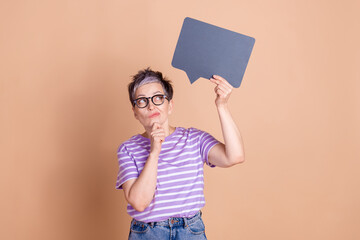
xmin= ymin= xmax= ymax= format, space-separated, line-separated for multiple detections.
xmin=133 ymin=82 xmax=173 ymax=129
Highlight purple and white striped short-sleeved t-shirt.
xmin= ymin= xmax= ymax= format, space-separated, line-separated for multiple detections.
xmin=116 ymin=127 xmax=218 ymax=222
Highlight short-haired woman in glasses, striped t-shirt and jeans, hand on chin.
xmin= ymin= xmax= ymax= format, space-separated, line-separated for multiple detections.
xmin=116 ymin=68 xmax=244 ymax=240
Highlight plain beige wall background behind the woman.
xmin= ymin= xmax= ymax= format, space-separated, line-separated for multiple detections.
xmin=0 ymin=0 xmax=360 ymax=240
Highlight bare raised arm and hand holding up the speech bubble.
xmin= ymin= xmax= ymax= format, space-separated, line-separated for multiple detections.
xmin=209 ymin=75 xmax=244 ymax=167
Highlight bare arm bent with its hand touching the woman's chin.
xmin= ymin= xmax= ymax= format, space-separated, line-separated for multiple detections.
xmin=123 ymin=123 xmax=165 ymax=212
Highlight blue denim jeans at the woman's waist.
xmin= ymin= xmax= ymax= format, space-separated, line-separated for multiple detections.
xmin=129 ymin=212 xmax=207 ymax=240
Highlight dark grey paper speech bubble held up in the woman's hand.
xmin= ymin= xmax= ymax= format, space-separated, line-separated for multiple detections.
xmin=171 ymin=17 xmax=255 ymax=87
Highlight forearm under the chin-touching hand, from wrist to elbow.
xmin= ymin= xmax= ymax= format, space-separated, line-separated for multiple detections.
xmin=128 ymin=154 xmax=159 ymax=211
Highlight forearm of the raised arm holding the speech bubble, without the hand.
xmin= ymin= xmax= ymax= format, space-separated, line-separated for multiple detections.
xmin=217 ymin=105 xmax=244 ymax=164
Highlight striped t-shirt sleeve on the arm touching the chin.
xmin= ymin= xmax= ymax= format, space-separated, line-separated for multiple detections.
xmin=116 ymin=144 xmax=139 ymax=189
